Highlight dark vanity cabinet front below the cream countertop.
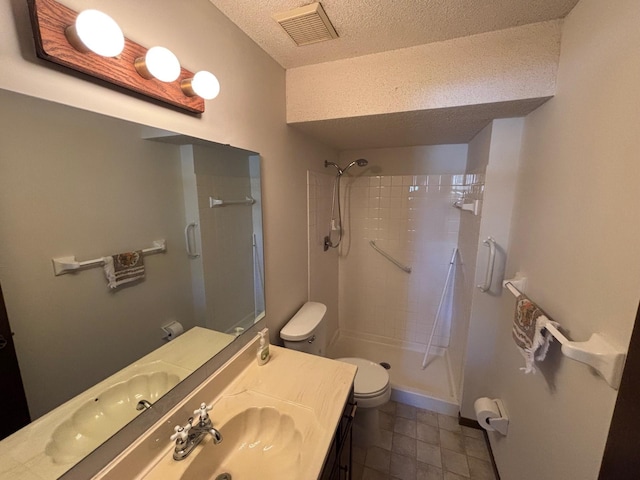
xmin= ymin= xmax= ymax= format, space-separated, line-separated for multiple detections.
xmin=320 ymin=388 xmax=357 ymax=480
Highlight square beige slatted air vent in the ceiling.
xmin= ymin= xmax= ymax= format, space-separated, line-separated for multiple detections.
xmin=273 ymin=2 xmax=338 ymax=47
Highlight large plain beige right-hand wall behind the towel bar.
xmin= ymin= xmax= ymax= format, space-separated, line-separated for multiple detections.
xmin=463 ymin=0 xmax=640 ymax=480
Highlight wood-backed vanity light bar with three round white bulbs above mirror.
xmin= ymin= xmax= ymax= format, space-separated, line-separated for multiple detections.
xmin=28 ymin=0 xmax=220 ymax=113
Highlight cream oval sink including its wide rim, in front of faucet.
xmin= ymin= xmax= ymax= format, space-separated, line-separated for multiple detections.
xmin=143 ymin=390 xmax=325 ymax=480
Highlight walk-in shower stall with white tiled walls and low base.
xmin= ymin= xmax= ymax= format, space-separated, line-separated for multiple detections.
xmin=308 ymin=145 xmax=483 ymax=415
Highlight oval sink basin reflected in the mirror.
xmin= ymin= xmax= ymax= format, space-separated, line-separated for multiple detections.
xmin=45 ymin=371 xmax=181 ymax=464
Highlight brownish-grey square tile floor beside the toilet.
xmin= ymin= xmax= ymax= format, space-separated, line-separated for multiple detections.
xmin=353 ymin=401 xmax=496 ymax=480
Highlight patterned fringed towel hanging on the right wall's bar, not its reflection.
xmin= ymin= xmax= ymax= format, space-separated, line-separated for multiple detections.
xmin=511 ymin=295 xmax=559 ymax=373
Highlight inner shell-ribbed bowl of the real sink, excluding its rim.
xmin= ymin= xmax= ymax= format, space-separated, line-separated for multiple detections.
xmin=181 ymin=407 xmax=303 ymax=480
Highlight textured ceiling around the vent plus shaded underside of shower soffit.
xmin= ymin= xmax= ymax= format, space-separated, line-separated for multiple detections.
xmin=210 ymin=0 xmax=578 ymax=150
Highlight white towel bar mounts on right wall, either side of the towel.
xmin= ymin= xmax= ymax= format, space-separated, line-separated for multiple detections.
xmin=502 ymin=275 xmax=627 ymax=390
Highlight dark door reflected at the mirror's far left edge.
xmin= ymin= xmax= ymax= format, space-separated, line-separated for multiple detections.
xmin=0 ymin=287 xmax=31 ymax=440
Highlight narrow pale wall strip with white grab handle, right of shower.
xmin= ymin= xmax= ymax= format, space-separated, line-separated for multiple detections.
xmin=460 ymin=118 xmax=524 ymax=408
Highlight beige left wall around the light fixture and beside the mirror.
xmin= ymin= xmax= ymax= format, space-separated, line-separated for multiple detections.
xmin=0 ymin=0 xmax=335 ymax=348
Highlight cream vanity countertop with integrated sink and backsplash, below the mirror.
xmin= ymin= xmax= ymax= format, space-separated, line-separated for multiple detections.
xmin=97 ymin=342 xmax=356 ymax=480
